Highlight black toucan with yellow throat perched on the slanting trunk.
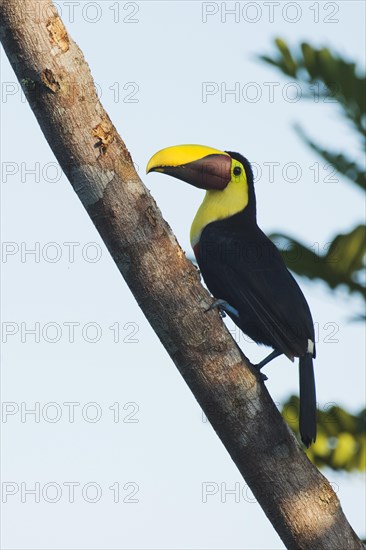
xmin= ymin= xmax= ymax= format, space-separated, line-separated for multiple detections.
xmin=146 ymin=145 xmax=316 ymax=447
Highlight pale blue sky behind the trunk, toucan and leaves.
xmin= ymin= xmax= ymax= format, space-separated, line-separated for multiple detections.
xmin=1 ymin=0 xmax=365 ymax=550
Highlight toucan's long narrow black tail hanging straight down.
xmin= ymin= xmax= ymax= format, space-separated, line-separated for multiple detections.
xmin=299 ymin=353 xmax=316 ymax=447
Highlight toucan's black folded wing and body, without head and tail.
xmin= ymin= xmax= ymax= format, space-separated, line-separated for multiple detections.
xmin=198 ymin=220 xmax=315 ymax=358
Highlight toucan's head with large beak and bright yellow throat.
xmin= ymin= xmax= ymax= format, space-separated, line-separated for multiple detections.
xmin=146 ymin=145 xmax=256 ymax=250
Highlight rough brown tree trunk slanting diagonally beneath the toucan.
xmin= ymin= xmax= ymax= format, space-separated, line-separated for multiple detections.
xmin=0 ymin=0 xmax=363 ymax=550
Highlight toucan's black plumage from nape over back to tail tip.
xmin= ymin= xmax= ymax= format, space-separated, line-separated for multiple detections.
xmin=195 ymin=152 xmax=316 ymax=446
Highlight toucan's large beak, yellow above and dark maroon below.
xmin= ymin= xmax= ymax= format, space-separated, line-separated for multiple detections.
xmin=146 ymin=145 xmax=231 ymax=190
